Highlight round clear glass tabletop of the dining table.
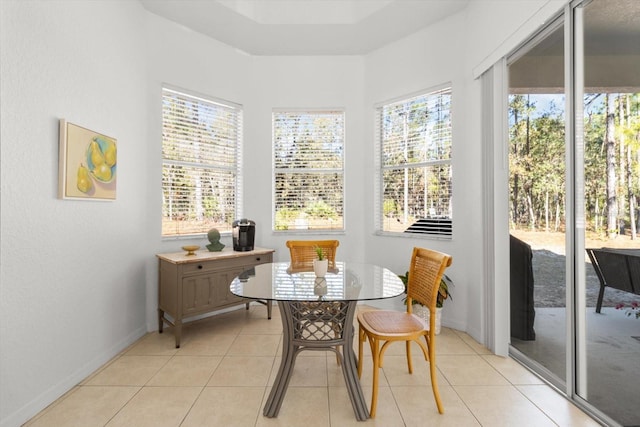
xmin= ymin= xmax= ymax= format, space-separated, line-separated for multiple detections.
xmin=229 ymin=262 xmax=404 ymax=301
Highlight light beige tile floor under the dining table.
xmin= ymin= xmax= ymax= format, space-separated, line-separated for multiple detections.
xmin=25 ymin=304 xmax=598 ymax=427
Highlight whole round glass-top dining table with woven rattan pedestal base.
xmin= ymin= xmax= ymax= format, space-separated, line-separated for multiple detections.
xmin=229 ymin=262 xmax=404 ymax=421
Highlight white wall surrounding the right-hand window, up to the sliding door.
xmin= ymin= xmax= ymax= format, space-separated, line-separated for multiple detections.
xmin=364 ymin=0 xmax=564 ymax=342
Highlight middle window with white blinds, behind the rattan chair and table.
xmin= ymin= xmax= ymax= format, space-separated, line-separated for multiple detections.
xmin=273 ymin=111 xmax=344 ymax=231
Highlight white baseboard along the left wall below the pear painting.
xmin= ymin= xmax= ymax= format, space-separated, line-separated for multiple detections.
xmin=0 ymin=327 xmax=147 ymax=427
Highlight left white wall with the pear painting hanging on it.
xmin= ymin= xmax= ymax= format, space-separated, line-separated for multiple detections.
xmin=0 ymin=0 xmax=149 ymax=426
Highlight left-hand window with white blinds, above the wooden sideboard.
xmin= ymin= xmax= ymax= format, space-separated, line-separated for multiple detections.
xmin=162 ymin=88 xmax=242 ymax=236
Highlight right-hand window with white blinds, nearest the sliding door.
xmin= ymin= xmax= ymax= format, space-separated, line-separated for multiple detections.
xmin=376 ymin=88 xmax=452 ymax=239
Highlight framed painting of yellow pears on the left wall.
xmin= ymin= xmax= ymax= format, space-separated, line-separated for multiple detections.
xmin=58 ymin=119 xmax=118 ymax=200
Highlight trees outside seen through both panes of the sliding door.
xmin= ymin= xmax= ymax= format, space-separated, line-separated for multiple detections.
xmin=509 ymin=93 xmax=640 ymax=237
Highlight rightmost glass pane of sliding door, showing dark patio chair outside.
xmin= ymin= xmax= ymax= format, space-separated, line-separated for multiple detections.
xmin=577 ymin=0 xmax=640 ymax=426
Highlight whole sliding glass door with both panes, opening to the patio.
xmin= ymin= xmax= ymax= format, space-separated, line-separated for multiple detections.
xmin=507 ymin=0 xmax=640 ymax=426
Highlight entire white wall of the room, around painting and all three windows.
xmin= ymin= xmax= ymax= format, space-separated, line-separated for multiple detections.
xmin=0 ymin=0 xmax=568 ymax=427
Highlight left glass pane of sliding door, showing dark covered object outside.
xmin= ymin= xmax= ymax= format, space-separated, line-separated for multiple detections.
xmin=509 ymin=25 xmax=567 ymax=383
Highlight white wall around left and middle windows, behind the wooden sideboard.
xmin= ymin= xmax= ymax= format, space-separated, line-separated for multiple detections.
xmin=146 ymin=15 xmax=366 ymax=330
